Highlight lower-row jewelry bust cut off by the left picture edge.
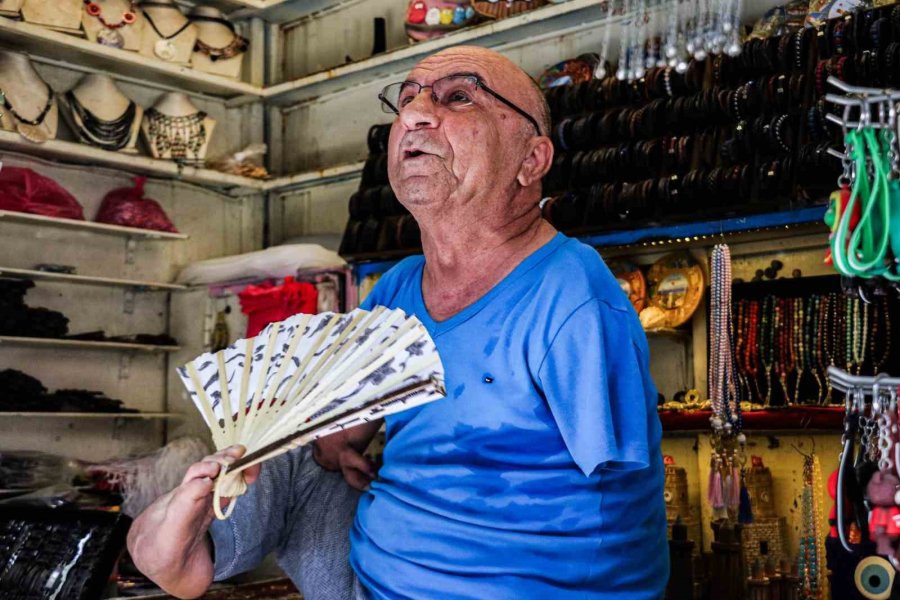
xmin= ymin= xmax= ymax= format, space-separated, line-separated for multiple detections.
xmin=0 ymin=51 xmax=59 ymax=143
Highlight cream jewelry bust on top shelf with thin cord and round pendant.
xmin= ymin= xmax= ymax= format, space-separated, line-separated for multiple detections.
xmin=140 ymin=0 xmax=197 ymax=65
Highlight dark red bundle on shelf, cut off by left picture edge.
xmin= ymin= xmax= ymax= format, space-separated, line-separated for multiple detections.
xmin=0 ymin=167 xmax=84 ymax=221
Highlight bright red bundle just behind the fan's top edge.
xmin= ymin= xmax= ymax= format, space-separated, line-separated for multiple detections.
xmin=238 ymin=277 xmax=319 ymax=337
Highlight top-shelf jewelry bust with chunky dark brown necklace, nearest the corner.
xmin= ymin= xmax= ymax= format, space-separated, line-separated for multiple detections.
xmin=190 ymin=6 xmax=247 ymax=79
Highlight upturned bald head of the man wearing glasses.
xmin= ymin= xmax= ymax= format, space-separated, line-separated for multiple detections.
xmin=388 ymin=46 xmax=553 ymax=234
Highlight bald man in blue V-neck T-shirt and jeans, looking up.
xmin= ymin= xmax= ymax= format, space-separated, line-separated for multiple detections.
xmin=129 ymin=48 xmax=669 ymax=600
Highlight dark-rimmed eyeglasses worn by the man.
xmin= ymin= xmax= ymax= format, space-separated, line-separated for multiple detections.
xmin=378 ymin=75 xmax=541 ymax=135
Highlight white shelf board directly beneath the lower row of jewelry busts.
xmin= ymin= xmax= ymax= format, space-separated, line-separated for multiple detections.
xmin=0 ymin=130 xmax=266 ymax=192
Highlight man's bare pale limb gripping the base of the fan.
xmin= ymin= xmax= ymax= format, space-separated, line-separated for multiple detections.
xmin=128 ymin=446 xmax=260 ymax=598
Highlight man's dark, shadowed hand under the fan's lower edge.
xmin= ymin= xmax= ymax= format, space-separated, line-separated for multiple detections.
xmin=313 ymin=421 xmax=381 ymax=491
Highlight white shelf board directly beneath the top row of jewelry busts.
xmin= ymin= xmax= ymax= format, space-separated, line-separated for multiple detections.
xmin=0 ymin=17 xmax=262 ymax=98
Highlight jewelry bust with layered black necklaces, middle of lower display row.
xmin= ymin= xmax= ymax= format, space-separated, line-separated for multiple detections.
xmin=60 ymin=74 xmax=144 ymax=154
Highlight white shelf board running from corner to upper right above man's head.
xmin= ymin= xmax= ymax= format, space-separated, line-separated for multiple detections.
xmin=264 ymin=0 xmax=608 ymax=106
